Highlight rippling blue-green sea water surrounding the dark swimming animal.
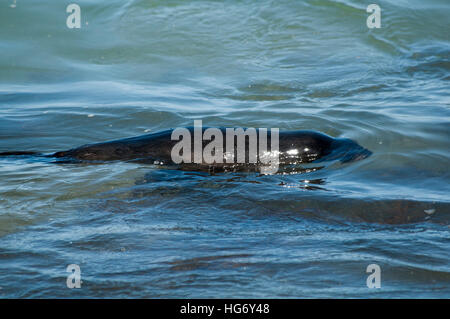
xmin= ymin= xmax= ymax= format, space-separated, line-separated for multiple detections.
xmin=0 ymin=0 xmax=450 ymax=298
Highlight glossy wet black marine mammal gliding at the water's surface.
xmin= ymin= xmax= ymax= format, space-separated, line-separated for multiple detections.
xmin=0 ymin=127 xmax=372 ymax=171
